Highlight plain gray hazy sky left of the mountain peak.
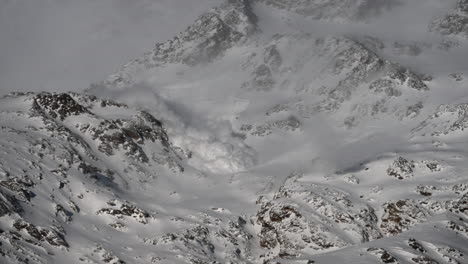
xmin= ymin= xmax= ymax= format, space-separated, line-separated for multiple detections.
xmin=0 ymin=0 xmax=219 ymax=93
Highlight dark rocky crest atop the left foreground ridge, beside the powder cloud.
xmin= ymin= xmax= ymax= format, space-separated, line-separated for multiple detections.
xmin=32 ymin=93 xmax=183 ymax=172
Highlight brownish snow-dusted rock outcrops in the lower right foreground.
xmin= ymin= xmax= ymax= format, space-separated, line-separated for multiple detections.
xmin=252 ymin=157 xmax=468 ymax=263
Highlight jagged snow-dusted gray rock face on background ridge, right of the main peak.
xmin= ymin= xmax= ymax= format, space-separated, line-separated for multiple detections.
xmin=274 ymin=36 xmax=429 ymax=125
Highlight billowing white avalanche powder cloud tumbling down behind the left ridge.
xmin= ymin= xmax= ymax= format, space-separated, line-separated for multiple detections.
xmin=90 ymin=83 xmax=257 ymax=174
